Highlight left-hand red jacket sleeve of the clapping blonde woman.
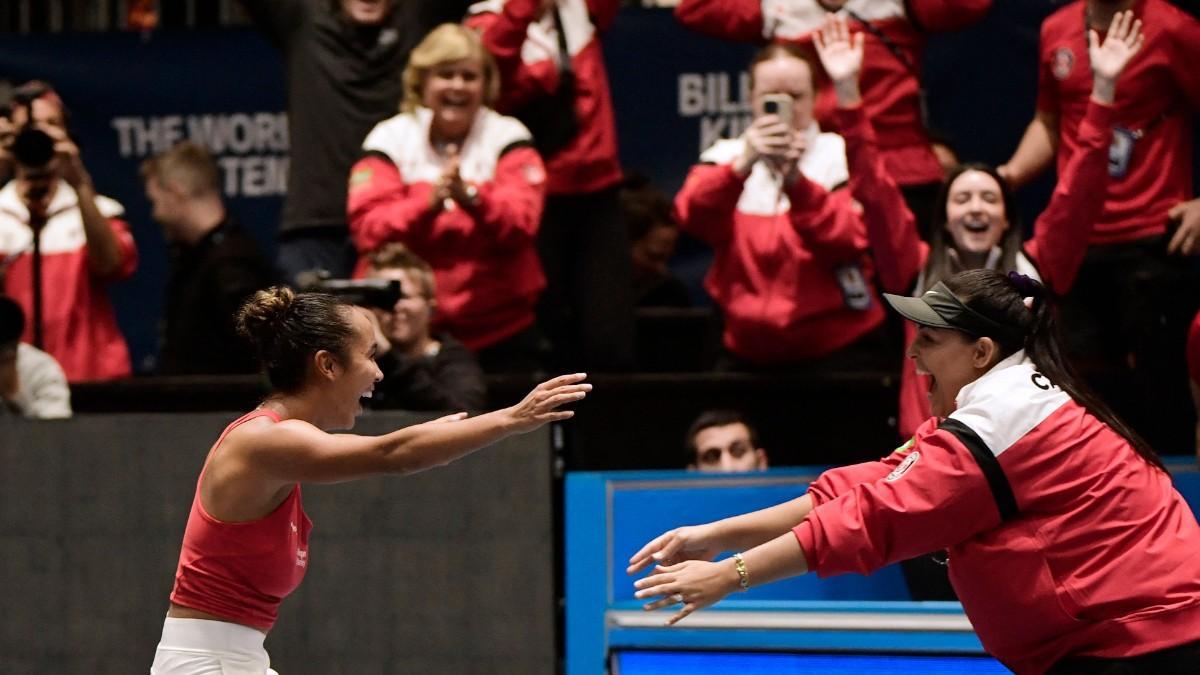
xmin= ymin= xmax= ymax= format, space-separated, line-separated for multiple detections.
xmin=347 ymin=155 xmax=434 ymax=253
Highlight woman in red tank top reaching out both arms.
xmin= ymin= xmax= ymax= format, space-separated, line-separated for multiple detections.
xmin=151 ymin=287 xmax=592 ymax=675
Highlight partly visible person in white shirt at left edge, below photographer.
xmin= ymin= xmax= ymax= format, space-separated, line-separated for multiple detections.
xmin=0 ymin=295 xmax=71 ymax=419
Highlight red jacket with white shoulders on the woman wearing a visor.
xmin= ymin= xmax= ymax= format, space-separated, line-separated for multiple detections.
xmin=793 ymin=352 xmax=1200 ymax=673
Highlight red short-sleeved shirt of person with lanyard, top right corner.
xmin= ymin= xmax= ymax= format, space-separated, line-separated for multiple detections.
xmin=1038 ymin=0 xmax=1200 ymax=244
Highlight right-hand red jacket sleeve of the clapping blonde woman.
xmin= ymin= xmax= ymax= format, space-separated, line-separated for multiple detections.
xmin=475 ymin=147 xmax=546 ymax=246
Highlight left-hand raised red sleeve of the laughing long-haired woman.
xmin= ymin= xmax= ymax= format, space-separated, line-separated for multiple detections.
xmin=835 ymin=106 xmax=929 ymax=293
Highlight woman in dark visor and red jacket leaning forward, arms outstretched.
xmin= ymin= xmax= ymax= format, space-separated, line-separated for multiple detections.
xmin=629 ymin=269 xmax=1200 ymax=674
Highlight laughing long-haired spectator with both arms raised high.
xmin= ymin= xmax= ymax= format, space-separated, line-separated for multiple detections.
xmin=816 ymin=14 xmax=1141 ymax=438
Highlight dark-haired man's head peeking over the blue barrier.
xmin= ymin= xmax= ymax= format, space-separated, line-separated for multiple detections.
xmin=686 ymin=410 xmax=767 ymax=473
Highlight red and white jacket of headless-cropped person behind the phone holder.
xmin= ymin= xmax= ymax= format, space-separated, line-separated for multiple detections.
xmin=676 ymin=0 xmax=991 ymax=186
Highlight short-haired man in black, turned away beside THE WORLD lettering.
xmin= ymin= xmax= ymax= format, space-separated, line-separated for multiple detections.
xmin=142 ymin=141 xmax=276 ymax=375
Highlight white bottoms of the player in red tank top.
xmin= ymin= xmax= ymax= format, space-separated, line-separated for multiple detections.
xmin=150 ymin=616 xmax=278 ymax=675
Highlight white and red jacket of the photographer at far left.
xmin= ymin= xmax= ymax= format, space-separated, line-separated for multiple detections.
xmin=0 ymin=180 xmax=138 ymax=382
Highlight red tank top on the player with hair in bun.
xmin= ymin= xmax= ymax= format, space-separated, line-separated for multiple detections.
xmin=170 ymin=410 xmax=312 ymax=631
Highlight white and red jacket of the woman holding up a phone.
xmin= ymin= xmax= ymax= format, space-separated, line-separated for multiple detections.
xmin=676 ymin=124 xmax=883 ymax=364
